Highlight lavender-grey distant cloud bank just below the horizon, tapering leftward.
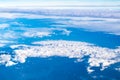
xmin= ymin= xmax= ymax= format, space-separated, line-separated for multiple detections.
xmin=0 ymin=8 xmax=120 ymax=18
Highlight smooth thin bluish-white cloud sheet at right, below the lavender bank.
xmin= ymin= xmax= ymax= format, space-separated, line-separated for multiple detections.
xmin=53 ymin=17 xmax=120 ymax=35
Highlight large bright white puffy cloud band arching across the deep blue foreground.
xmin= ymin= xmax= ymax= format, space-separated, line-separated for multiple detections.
xmin=0 ymin=40 xmax=120 ymax=72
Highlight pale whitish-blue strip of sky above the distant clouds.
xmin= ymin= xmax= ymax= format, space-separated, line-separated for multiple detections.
xmin=0 ymin=0 xmax=120 ymax=6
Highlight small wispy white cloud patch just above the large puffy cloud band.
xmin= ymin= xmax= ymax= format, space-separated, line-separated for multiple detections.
xmin=21 ymin=27 xmax=71 ymax=38
